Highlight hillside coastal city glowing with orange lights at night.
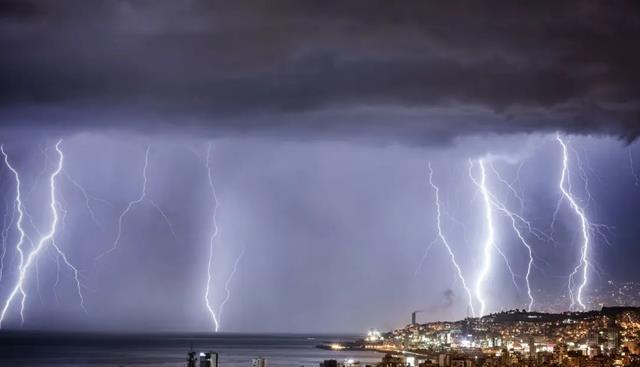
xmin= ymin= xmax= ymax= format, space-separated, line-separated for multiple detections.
xmin=322 ymin=307 xmax=640 ymax=367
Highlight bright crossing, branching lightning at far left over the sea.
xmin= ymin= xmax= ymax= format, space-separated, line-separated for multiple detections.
xmin=0 ymin=140 xmax=86 ymax=329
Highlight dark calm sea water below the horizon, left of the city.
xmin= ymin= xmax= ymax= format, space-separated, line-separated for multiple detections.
xmin=0 ymin=333 xmax=382 ymax=367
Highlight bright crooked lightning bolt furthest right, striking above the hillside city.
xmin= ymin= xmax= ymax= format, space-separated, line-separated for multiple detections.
xmin=556 ymin=132 xmax=591 ymax=310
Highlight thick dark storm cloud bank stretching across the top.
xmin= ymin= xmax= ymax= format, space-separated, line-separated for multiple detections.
xmin=0 ymin=1 xmax=640 ymax=143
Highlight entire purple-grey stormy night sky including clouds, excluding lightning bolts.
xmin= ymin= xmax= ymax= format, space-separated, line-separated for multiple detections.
xmin=0 ymin=0 xmax=640 ymax=332
